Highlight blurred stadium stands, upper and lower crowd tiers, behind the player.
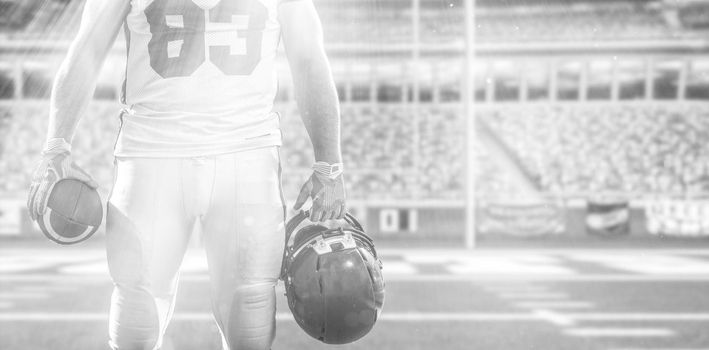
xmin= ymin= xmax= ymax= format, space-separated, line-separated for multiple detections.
xmin=0 ymin=0 xmax=709 ymax=205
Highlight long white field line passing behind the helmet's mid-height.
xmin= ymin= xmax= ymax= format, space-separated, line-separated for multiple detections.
xmin=0 ymin=270 xmax=709 ymax=283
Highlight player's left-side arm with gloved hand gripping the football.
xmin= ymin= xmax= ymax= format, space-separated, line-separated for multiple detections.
xmin=27 ymin=0 xmax=130 ymax=219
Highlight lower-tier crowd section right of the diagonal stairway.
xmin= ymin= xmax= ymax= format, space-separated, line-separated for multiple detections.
xmin=480 ymin=103 xmax=709 ymax=194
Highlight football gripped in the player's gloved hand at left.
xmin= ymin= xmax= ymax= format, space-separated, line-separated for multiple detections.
xmin=37 ymin=179 xmax=103 ymax=244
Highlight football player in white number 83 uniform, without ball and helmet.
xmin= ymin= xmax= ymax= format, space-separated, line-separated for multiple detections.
xmin=28 ymin=0 xmax=345 ymax=350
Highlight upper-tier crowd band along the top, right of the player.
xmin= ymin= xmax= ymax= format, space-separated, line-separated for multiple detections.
xmin=320 ymin=1 xmax=676 ymax=44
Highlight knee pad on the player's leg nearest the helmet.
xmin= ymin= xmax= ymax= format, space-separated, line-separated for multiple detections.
xmin=214 ymin=283 xmax=276 ymax=350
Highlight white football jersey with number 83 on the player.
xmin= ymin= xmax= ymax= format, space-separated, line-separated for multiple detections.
xmin=115 ymin=0 xmax=282 ymax=157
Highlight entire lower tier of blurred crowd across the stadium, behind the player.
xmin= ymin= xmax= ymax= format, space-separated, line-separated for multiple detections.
xmin=0 ymin=102 xmax=709 ymax=200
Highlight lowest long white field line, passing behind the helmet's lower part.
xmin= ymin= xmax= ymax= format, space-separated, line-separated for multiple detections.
xmin=0 ymin=310 xmax=709 ymax=323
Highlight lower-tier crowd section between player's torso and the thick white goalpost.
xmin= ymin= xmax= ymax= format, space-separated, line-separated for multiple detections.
xmin=281 ymin=105 xmax=464 ymax=199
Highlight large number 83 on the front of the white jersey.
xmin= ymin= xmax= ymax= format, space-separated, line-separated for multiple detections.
xmin=144 ymin=0 xmax=268 ymax=78
